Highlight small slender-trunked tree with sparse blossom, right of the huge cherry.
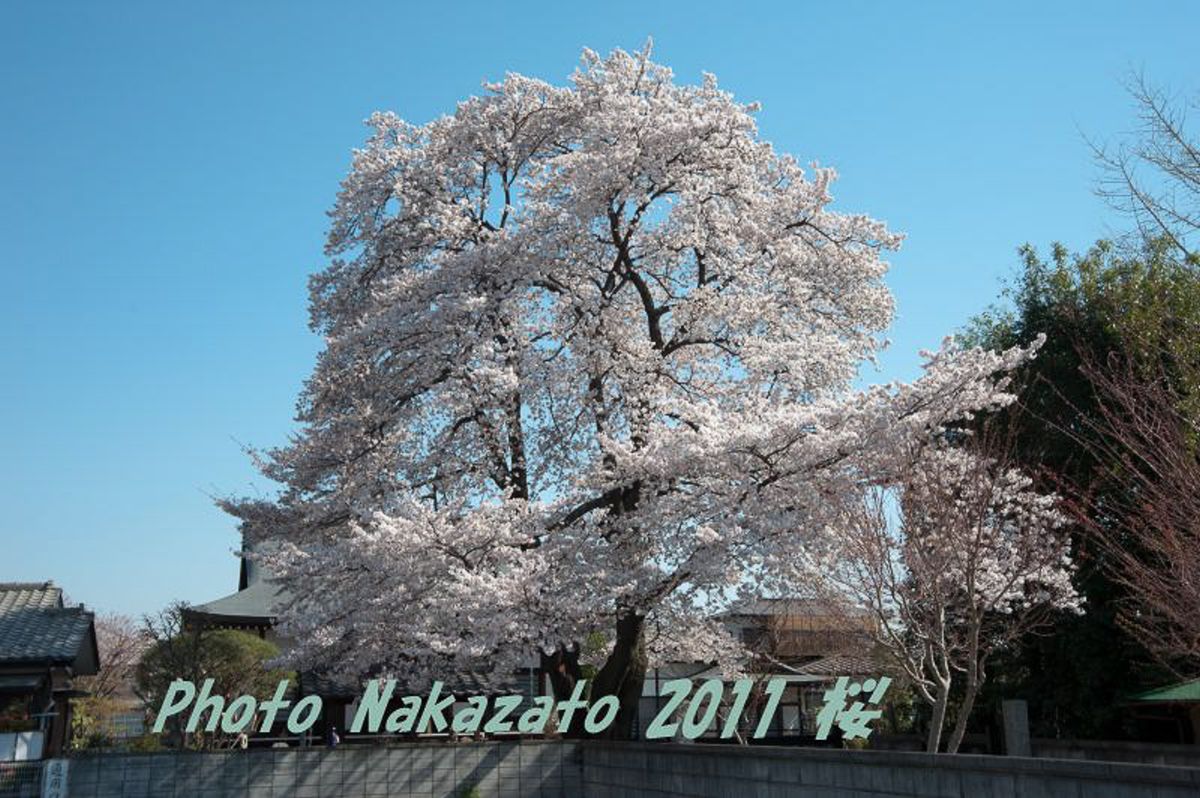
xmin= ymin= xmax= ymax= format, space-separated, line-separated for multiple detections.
xmin=815 ymin=430 xmax=1076 ymax=752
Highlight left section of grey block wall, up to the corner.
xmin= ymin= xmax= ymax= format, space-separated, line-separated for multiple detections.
xmin=70 ymin=742 xmax=581 ymax=798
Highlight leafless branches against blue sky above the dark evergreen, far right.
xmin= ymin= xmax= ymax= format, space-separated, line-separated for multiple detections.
xmin=1092 ymin=74 xmax=1200 ymax=264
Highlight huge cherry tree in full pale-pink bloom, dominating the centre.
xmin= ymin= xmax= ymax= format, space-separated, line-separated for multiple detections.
xmin=223 ymin=49 xmax=1030 ymax=733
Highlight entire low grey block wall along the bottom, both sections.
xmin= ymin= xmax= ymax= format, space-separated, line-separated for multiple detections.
xmin=11 ymin=740 xmax=1200 ymax=798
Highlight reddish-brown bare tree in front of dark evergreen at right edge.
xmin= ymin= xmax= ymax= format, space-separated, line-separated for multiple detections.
xmin=1069 ymin=356 xmax=1200 ymax=673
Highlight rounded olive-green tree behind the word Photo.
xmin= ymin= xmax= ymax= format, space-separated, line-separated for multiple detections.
xmin=137 ymin=601 xmax=294 ymax=748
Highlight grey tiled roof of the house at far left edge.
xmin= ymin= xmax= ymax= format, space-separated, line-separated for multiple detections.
xmin=0 ymin=582 xmax=95 ymax=668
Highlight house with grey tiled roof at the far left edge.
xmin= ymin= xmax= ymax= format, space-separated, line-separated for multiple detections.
xmin=0 ymin=582 xmax=100 ymax=760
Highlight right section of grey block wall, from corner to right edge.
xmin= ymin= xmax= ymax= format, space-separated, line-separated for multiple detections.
xmin=582 ymin=742 xmax=1200 ymax=798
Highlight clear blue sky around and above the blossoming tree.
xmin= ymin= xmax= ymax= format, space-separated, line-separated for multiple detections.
xmin=0 ymin=0 xmax=1200 ymax=614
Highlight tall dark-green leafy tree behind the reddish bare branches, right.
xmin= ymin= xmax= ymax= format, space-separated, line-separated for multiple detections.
xmin=965 ymin=241 xmax=1200 ymax=738
